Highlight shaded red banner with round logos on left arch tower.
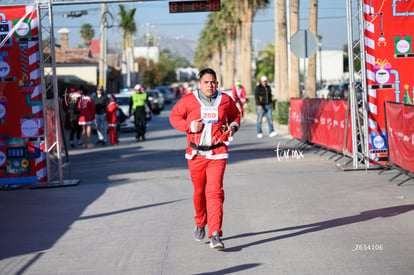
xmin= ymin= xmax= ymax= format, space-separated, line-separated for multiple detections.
xmin=0 ymin=5 xmax=44 ymax=184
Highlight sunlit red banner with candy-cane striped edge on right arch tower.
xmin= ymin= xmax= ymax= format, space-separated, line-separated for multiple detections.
xmin=363 ymin=0 xmax=414 ymax=164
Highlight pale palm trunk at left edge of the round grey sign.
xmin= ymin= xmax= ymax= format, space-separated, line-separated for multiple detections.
xmin=289 ymin=0 xmax=300 ymax=98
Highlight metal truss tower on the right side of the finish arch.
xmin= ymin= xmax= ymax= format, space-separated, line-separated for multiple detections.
xmin=346 ymin=0 xmax=370 ymax=169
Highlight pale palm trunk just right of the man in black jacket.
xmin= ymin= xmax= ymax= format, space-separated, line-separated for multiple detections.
xmin=275 ymin=0 xmax=289 ymax=101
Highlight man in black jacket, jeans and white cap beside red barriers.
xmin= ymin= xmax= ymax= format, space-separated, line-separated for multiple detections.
xmin=254 ymin=76 xmax=277 ymax=138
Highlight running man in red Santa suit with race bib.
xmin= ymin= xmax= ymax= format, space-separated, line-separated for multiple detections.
xmin=170 ymin=68 xmax=240 ymax=249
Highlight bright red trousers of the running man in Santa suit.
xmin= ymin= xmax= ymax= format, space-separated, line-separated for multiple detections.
xmin=188 ymin=156 xmax=227 ymax=238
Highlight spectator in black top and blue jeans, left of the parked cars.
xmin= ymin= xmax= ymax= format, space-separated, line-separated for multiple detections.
xmin=93 ymin=85 xmax=108 ymax=145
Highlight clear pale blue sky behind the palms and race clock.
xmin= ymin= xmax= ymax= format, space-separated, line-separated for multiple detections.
xmin=11 ymin=0 xmax=347 ymax=53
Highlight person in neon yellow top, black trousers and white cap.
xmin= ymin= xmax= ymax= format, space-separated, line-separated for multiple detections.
xmin=129 ymin=84 xmax=149 ymax=142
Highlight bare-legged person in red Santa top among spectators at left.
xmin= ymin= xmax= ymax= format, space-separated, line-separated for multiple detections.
xmin=78 ymin=90 xmax=95 ymax=147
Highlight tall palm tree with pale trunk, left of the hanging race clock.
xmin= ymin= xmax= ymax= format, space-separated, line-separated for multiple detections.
xmin=119 ymin=5 xmax=137 ymax=87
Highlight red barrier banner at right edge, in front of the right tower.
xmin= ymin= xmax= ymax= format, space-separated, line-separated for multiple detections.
xmin=385 ymin=102 xmax=414 ymax=173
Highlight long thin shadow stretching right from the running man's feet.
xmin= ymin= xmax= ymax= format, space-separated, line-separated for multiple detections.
xmin=221 ymin=204 xmax=414 ymax=252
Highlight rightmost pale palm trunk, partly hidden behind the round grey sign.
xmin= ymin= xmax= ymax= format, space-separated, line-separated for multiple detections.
xmin=306 ymin=0 xmax=318 ymax=98
